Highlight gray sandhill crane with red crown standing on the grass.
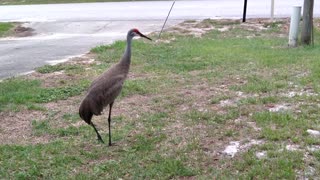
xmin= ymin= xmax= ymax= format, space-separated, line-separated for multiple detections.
xmin=79 ymin=29 xmax=151 ymax=146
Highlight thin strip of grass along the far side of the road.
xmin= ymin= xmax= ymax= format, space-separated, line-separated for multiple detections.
xmin=0 ymin=0 xmax=165 ymax=5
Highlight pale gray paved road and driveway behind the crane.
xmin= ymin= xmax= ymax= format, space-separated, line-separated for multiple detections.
xmin=0 ymin=0 xmax=320 ymax=79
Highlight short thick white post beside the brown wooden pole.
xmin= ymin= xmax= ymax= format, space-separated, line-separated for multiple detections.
xmin=289 ymin=6 xmax=301 ymax=47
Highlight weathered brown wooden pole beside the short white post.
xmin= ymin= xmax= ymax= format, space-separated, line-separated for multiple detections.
xmin=301 ymin=0 xmax=314 ymax=45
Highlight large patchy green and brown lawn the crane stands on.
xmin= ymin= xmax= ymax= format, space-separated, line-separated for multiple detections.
xmin=0 ymin=20 xmax=320 ymax=179
